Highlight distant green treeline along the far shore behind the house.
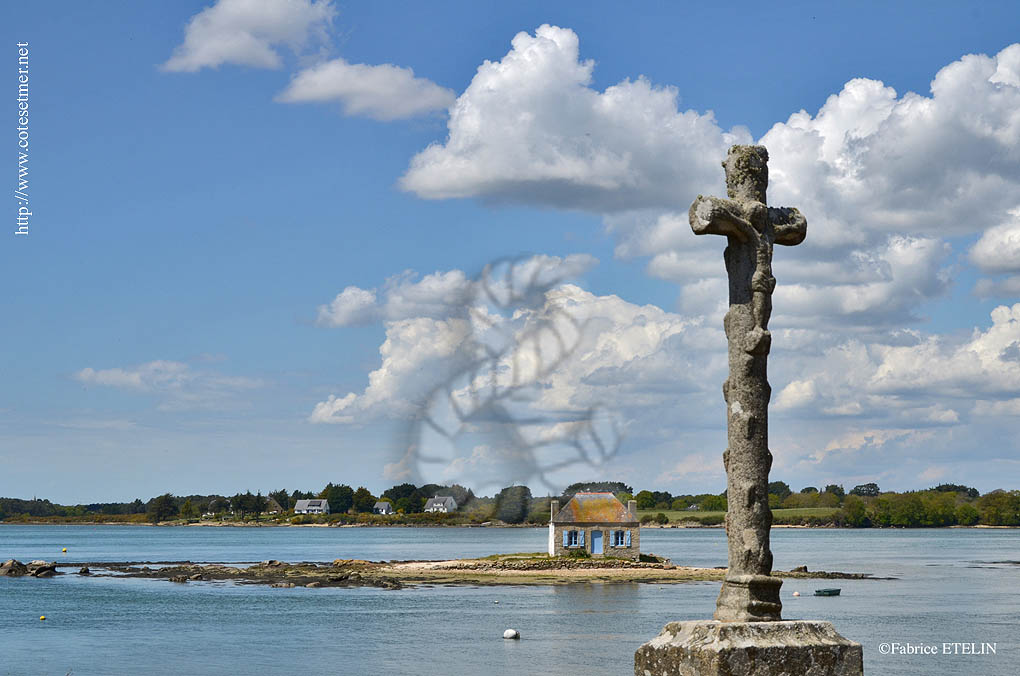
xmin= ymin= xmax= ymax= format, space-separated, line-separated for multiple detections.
xmin=0 ymin=481 xmax=1020 ymax=527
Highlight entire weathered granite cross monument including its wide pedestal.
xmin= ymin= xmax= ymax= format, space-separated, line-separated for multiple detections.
xmin=634 ymin=146 xmax=864 ymax=676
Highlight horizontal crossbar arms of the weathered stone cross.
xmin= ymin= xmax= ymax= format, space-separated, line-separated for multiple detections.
xmin=687 ymin=195 xmax=808 ymax=247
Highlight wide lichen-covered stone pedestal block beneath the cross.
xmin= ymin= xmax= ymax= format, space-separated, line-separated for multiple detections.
xmin=634 ymin=620 xmax=864 ymax=676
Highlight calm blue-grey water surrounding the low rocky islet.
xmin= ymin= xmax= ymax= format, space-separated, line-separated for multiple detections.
xmin=0 ymin=525 xmax=1020 ymax=676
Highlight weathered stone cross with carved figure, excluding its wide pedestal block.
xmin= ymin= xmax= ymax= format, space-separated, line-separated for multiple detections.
xmin=690 ymin=146 xmax=808 ymax=622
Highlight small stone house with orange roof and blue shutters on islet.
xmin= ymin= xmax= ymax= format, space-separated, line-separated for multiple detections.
xmin=549 ymin=492 xmax=641 ymax=561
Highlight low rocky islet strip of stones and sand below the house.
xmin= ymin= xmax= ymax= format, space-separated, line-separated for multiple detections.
xmin=0 ymin=555 xmax=891 ymax=589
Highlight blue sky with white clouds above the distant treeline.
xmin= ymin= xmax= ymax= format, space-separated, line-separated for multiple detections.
xmin=0 ymin=0 xmax=1020 ymax=502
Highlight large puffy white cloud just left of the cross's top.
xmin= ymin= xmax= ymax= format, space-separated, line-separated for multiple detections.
xmin=401 ymin=24 xmax=750 ymax=211
